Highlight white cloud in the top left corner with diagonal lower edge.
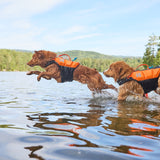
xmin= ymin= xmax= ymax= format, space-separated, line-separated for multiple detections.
xmin=0 ymin=0 xmax=66 ymax=18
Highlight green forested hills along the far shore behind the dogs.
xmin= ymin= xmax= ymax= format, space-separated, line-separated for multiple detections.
xmin=0 ymin=49 xmax=142 ymax=72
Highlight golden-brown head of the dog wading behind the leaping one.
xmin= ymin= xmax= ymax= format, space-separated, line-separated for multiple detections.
xmin=103 ymin=61 xmax=134 ymax=82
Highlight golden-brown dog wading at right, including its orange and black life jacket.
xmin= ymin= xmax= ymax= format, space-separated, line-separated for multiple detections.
xmin=103 ymin=61 xmax=160 ymax=100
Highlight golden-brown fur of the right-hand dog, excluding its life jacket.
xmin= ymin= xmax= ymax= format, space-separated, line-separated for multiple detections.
xmin=103 ymin=61 xmax=160 ymax=101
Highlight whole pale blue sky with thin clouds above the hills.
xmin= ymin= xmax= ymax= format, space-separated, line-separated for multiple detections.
xmin=0 ymin=0 xmax=160 ymax=56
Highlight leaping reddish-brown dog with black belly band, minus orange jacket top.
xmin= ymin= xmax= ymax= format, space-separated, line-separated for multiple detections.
xmin=27 ymin=50 xmax=116 ymax=92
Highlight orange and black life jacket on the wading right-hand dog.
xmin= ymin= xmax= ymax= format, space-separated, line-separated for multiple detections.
xmin=117 ymin=67 xmax=160 ymax=94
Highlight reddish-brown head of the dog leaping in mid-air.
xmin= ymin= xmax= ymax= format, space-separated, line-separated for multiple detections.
xmin=27 ymin=50 xmax=57 ymax=67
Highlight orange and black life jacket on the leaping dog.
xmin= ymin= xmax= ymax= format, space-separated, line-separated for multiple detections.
xmin=45 ymin=57 xmax=80 ymax=82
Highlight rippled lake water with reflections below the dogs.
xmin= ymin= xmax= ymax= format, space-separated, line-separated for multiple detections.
xmin=0 ymin=72 xmax=160 ymax=160
